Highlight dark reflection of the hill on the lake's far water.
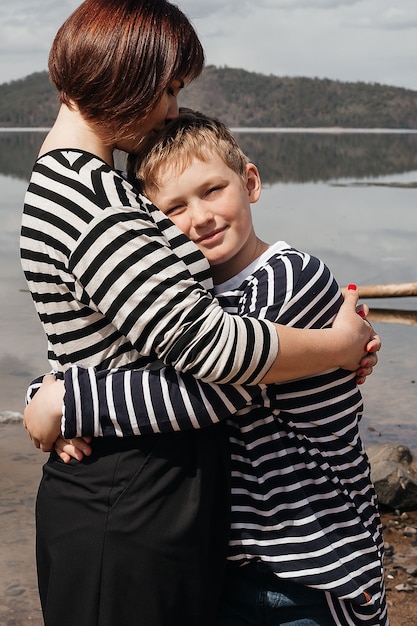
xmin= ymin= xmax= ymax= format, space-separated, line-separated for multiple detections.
xmin=0 ymin=131 xmax=417 ymax=184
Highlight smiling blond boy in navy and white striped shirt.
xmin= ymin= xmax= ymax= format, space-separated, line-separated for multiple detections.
xmin=25 ymin=111 xmax=388 ymax=626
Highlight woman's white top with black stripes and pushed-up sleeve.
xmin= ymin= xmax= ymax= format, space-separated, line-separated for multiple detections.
xmin=21 ymin=149 xmax=278 ymax=384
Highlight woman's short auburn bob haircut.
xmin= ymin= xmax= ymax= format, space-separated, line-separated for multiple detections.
xmin=49 ymin=0 xmax=204 ymax=142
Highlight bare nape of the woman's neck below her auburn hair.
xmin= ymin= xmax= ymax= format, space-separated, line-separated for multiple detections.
xmin=39 ymin=104 xmax=113 ymax=167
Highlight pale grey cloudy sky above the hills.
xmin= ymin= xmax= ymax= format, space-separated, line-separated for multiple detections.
xmin=0 ymin=0 xmax=417 ymax=90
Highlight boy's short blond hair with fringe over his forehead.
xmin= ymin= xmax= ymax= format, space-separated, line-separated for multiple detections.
xmin=127 ymin=108 xmax=249 ymax=194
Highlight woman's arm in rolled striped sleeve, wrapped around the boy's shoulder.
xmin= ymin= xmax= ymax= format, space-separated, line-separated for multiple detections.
xmin=66 ymin=209 xmax=372 ymax=384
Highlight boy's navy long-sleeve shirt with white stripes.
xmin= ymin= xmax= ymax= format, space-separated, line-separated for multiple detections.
xmin=61 ymin=242 xmax=388 ymax=626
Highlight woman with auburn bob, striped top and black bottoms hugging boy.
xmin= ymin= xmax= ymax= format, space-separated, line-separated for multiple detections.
xmin=21 ymin=0 xmax=379 ymax=626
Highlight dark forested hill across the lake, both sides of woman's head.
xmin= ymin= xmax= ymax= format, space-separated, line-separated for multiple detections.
xmin=0 ymin=65 xmax=417 ymax=129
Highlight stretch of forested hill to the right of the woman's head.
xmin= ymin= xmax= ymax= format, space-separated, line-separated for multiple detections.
xmin=182 ymin=65 xmax=417 ymax=128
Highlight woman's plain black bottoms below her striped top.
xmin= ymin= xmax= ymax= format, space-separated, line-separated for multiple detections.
xmin=36 ymin=424 xmax=230 ymax=626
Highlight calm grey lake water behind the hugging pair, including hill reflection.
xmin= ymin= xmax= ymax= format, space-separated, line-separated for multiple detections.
xmin=0 ymin=132 xmax=417 ymax=452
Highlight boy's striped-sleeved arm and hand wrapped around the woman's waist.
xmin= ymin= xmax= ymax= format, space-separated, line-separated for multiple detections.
xmin=24 ymin=366 xmax=261 ymax=451
